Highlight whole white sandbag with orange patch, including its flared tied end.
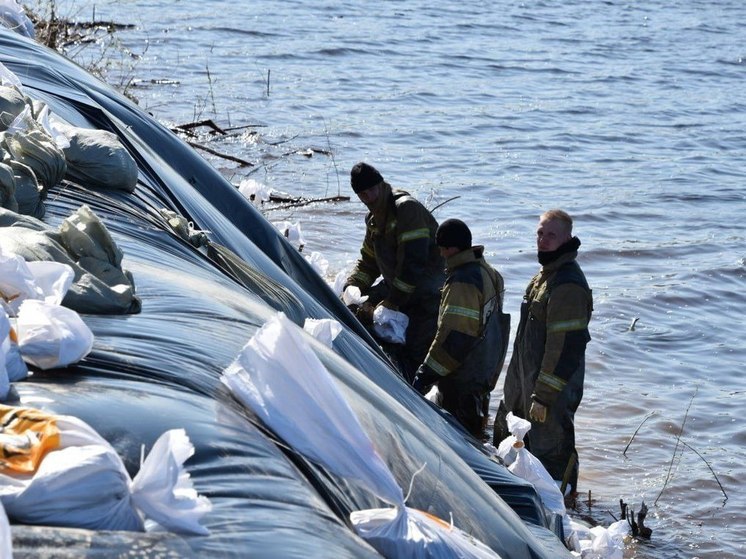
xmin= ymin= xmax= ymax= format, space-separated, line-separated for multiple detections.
xmin=0 ymin=405 xmax=209 ymax=534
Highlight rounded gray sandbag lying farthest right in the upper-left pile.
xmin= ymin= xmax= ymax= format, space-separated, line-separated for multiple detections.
xmin=61 ymin=126 xmax=137 ymax=193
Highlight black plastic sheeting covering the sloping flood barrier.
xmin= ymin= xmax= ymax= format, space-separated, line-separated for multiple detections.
xmin=0 ymin=31 xmax=570 ymax=559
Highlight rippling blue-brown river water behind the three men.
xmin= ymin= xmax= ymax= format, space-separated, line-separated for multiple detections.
xmin=42 ymin=0 xmax=746 ymax=559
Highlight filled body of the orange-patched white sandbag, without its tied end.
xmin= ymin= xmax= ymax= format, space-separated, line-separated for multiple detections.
xmin=0 ymin=405 xmax=143 ymax=531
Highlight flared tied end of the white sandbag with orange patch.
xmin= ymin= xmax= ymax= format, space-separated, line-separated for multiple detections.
xmin=131 ymin=429 xmax=212 ymax=536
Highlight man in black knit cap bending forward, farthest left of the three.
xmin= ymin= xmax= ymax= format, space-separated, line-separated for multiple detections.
xmin=345 ymin=162 xmax=445 ymax=383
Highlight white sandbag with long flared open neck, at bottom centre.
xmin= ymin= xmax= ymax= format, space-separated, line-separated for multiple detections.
xmin=221 ymin=313 xmax=499 ymax=559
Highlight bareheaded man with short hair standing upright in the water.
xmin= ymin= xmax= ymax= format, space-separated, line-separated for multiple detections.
xmin=494 ymin=210 xmax=593 ymax=493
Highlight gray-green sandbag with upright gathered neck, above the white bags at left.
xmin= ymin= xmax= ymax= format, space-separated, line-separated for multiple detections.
xmin=0 ymin=206 xmax=141 ymax=314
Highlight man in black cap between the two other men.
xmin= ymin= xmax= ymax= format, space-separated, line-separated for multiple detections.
xmin=414 ymin=219 xmax=510 ymax=440
